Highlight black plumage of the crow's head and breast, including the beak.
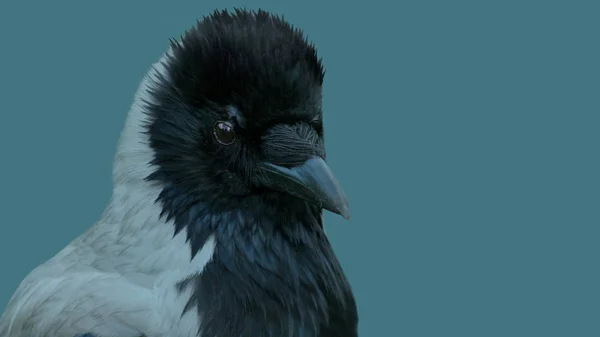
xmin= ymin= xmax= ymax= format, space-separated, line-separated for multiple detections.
xmin=145 ymin=10 xmax=358 ymax=337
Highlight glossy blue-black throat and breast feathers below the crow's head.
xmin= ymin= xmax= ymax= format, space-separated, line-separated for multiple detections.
xmin=161 ymin=184 xmax=356 ymax=337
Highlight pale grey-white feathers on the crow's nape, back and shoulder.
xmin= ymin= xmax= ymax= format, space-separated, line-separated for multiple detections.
xmin=0 ymin=52 xmax=215 ymax=337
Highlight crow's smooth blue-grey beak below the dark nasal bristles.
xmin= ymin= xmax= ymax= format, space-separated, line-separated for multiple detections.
xmin=262 ymin=156 xmax=350 ymax=220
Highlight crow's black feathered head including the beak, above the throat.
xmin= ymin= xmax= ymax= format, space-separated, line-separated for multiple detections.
xmin=147 ymin=11 xmax=349 ymax=218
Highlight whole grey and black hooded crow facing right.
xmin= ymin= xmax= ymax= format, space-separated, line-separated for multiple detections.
xmin=0 ymin=9 xmax=358 ymax=337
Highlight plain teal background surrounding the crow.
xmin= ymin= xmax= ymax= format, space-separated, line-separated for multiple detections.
xmin=0 ymin=0 xmax=600 ymax=337
